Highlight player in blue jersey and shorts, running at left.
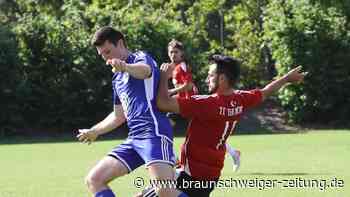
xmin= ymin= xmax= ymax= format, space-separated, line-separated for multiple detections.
xmin=77 ymin=27 xmax=187 ymax=197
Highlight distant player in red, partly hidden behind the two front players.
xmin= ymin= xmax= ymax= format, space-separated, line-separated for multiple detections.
xmin=167 ymin=39 xmax=241 ymax=171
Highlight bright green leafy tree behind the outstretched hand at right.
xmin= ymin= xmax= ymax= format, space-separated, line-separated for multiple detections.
xmin=265 ymin=0 xmax=350 ymax=123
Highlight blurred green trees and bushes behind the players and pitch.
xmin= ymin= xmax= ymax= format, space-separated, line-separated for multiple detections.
xmin=0 ymin=0 xmax=350 ymax=132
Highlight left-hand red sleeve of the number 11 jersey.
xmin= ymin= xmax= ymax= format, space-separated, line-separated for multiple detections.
xmin=177 ymin=95 xmax=213 ymax=119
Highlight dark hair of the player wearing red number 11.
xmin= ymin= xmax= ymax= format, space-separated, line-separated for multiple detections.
xmin=209 ymin=54 xmax=240 ymax=86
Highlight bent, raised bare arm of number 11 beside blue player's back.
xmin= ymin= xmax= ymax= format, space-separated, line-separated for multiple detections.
xmin=157 ymin=63 xmax=180 ymax=113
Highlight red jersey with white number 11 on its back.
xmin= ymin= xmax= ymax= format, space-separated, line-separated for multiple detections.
xmin=178 ymin=90 xmax=262 ymax=180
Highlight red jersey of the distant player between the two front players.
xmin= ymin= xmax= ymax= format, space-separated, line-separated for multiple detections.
xmin=172 ymin=62 xmax=198 ymax=98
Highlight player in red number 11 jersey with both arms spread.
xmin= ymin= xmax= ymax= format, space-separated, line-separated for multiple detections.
xmin=138 ymin=55 xmax=305 ymax=197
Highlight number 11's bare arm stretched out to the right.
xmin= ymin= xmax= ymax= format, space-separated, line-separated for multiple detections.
xmin=261 ymin=66 xmax=307 ymax=100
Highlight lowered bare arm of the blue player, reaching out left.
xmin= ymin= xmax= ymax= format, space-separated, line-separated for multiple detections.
xmin=77 ymin=105 xmax=126 ymax=144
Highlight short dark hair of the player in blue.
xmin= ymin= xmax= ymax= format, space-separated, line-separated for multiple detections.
xmin=91 ymin=26 xmax=126 ymax=46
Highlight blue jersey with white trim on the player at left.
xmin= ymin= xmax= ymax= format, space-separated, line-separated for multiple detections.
xmin=112 ymin=51 xmax=173 ymax=142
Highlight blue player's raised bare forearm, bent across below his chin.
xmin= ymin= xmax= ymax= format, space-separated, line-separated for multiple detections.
xmin=106 ymin=58 xmax=152 ymax=79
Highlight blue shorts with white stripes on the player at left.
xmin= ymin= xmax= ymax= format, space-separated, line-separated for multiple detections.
xmin=108 ymin=137 xmax=175 ymax=172
